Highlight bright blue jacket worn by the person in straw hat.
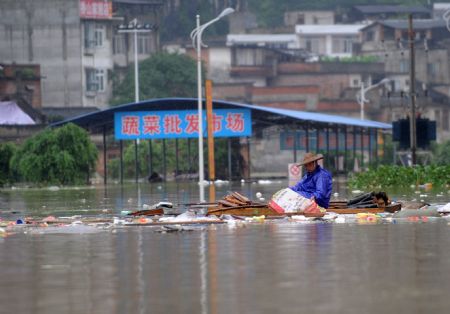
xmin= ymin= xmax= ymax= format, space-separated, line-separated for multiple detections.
xmin=290 ymin=165 xmax=333 ymax=208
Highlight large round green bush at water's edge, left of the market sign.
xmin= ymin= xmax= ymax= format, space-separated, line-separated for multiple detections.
xmin=11 ymin=124 xmax=97 ymax=185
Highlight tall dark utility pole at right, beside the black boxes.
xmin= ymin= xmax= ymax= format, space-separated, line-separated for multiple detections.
xmin=409 ymin=14 xmax=417 ymax=166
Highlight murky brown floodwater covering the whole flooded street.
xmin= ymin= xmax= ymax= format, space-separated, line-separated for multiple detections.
xmin=0 ymin=181 xmax=450 ymax=314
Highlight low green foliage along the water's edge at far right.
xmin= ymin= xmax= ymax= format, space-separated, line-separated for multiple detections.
xmin=349 ymin=165 xmax=450 ymax=190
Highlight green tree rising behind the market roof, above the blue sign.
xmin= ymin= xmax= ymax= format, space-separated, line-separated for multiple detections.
xmin=112 ymin=53 xmax=197 ymax=105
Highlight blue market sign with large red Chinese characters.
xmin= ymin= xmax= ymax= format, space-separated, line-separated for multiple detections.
xmin=114 ymin=109 xmax=252 ymax=140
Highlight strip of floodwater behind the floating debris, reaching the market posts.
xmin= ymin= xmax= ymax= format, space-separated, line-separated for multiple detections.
xmin=0 ymin=180 xmax=450 ymax=216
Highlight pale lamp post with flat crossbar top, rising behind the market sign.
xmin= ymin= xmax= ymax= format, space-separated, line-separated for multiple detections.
xmin=117 ymin=18 xmax=152 ymax=183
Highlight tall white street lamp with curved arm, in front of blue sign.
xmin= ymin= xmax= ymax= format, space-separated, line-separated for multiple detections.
xmin=190 ymin=8 xmax=234 ymax=202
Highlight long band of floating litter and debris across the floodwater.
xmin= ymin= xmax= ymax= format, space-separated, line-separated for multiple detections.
xmin=0 ymin=206 xmax=450 ymax=238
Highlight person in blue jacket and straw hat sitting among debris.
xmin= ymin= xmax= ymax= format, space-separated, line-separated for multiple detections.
xmin=290 ymin=153 xmax=333 ymax=208
